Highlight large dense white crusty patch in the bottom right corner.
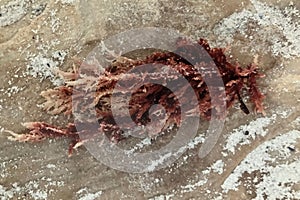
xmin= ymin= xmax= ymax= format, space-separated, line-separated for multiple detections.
xmin=221 ymin=130 xmax=300 ymax=199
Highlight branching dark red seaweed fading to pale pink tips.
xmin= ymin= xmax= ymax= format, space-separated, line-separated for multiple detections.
xmin=9 ymin=38 xmax=265 ymax=155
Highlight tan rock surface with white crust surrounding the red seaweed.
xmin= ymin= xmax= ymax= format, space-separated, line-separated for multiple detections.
xmin=0 ymin=0 xmax=300 ymax=200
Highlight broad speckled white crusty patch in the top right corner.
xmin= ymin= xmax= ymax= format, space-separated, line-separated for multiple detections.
xmin=213 ymin=0 xmax=300 ymax=58
